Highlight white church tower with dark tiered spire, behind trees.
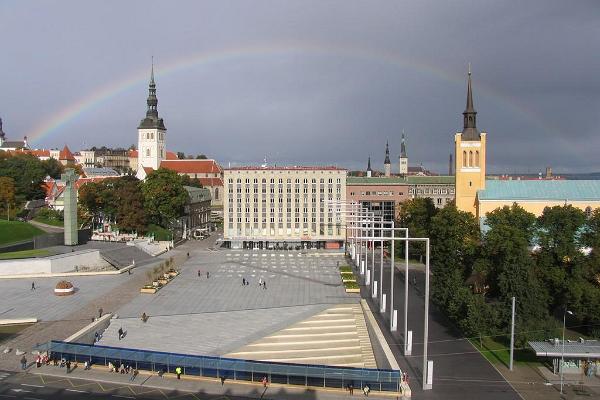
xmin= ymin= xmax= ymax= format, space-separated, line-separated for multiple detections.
xmin=137 ymin=60 xmax=167 ymax=177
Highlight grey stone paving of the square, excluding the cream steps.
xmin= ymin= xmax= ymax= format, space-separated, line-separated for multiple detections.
xmin=99 ymin=248 xmax=360 ymax=355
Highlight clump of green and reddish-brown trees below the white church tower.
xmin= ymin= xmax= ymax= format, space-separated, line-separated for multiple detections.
xmin=79 ymin=168 xmax=201 ymax=233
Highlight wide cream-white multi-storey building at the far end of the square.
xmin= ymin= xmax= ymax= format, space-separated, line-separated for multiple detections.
xmin=223 ymin=167 xmax=347 ymax=249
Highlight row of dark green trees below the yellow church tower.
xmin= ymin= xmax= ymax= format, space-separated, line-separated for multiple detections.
xmin=398 ymin=199 xmax=600 ymax=344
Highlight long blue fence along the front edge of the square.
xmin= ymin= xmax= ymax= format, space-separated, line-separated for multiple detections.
xmin=36 ymin=340 xmax=402 ymax=392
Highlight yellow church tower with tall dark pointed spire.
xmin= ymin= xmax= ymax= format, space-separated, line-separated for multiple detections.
xmin=454 ymin=64 xmax=487 ymax=217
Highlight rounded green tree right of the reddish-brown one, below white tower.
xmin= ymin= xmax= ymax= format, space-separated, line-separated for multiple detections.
xmin=142 ymin=168 xmax=188 ymax=227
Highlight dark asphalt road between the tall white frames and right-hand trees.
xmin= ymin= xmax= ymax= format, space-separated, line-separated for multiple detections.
xmin=362 ymin=251 xmax=521 ymax=400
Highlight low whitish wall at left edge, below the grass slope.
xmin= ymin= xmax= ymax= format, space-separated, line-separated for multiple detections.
xmin=0 ymin=250 xmax=106 ymax=276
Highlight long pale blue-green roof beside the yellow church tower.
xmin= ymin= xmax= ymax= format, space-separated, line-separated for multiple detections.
xmin=477 ymin=180 xmax=600 ymax=201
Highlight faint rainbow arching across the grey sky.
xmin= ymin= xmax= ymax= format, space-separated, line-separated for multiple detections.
xmin=27 ymin=42 xmax=555 ymax=143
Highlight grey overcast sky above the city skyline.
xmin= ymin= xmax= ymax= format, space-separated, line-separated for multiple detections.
xmin=0 ymin=0 xmax=600 ymax=173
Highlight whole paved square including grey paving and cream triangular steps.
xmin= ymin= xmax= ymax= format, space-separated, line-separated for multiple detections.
xmin=100 ymin=252 xmax=375 ymax=367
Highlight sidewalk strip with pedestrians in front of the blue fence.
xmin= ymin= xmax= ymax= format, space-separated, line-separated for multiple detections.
xmin=28 ymin=364 xmax=400 ymax=400
